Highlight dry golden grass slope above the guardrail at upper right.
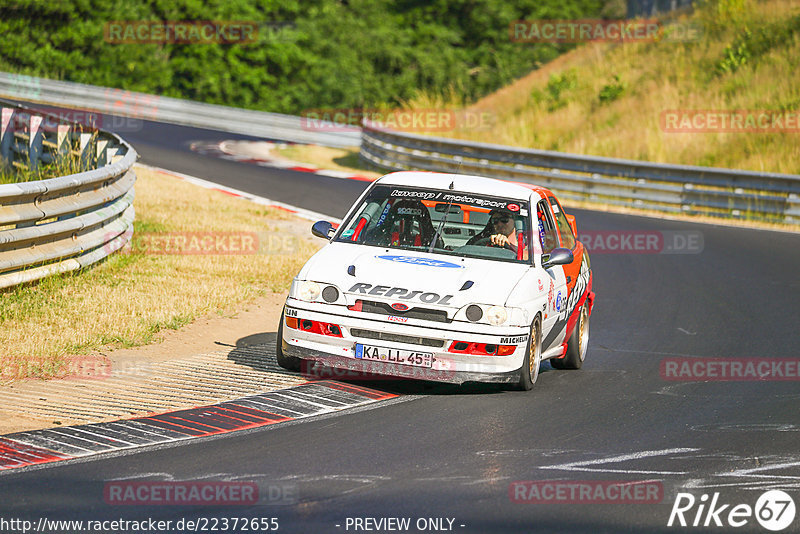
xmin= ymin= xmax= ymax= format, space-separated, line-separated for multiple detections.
xmin=432 ymin=0 xmax=800 ymax=174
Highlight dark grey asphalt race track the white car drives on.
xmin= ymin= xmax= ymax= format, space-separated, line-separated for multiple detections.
xmin=0 ymin=107 xmax=800 ymax=533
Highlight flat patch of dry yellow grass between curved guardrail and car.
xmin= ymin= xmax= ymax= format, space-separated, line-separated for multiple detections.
xmin=0 ymin=168 xmax=319 ymax=379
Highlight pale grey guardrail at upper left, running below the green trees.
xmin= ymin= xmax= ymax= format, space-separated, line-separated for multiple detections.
xmin=0 ymin=72 xmax=361 ymax=147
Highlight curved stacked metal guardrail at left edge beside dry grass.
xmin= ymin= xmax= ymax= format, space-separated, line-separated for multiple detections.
xmin=0 ymin=100 xmax=137 ymax=288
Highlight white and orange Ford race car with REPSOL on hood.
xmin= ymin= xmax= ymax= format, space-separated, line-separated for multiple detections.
xmin=277 ymin=172 xmax=594 ymax=390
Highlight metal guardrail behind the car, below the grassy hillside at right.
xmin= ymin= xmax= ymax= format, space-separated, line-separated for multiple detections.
xmin=360 ymin=122 xmax=800 ymax=224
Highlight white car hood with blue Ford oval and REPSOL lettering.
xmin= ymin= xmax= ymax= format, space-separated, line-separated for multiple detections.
xmin=298 ymin=243 xmax=529 ymax=308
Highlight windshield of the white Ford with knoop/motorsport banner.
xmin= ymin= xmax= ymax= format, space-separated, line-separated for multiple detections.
xmin=336 ymin=185 xmax=530 ymax=262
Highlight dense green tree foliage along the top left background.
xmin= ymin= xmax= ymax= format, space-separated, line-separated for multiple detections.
xmin=0 ymin=0 xmax=603 ymax=114
